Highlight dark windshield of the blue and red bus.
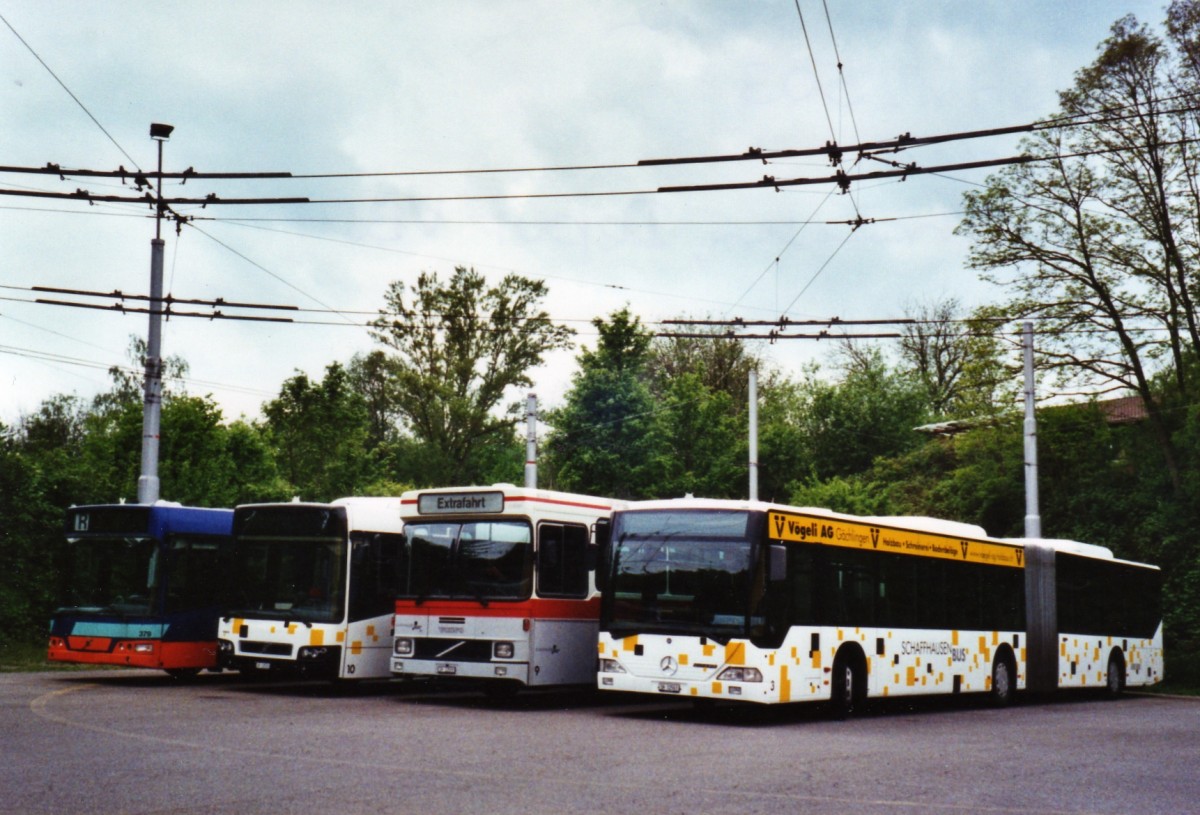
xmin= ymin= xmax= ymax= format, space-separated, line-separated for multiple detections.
xmin=60 ymin=535 xmax=160 ymax=615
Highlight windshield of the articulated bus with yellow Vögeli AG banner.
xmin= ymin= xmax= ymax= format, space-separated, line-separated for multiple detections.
xmin=605 ymin=510 xmax=754 ymax=640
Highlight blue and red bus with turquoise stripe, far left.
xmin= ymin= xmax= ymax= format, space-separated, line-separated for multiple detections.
xmin=47 ymin=501 xmax=233 ymax=677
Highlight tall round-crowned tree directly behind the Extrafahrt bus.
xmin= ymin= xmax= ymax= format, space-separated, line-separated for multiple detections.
xmin=372 ymin=266 xmax=572 ymax=485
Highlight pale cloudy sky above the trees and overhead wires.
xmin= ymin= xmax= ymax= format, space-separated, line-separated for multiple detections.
xmin=0 ymin=0 xmax=1164 ymax=425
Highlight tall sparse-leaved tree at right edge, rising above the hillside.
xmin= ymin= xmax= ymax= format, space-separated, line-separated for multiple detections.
xmin=959 ymin=6 xmax=1200 ymax=489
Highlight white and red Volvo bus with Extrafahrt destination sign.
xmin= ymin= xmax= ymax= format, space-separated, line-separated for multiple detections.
xmin=391 ymin=484 xmax=620 ymax=694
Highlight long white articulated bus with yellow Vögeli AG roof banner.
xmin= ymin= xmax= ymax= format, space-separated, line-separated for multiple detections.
xmin=598 ymin=498 xmax=1163 ymax=712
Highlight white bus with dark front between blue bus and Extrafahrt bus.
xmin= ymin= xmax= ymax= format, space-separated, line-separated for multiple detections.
xmin=220 ymin=498 xmax=403 ymax=679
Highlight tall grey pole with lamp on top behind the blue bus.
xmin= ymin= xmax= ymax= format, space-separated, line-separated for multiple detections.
xmin=138 ymin=124 xmax=175 ymax=504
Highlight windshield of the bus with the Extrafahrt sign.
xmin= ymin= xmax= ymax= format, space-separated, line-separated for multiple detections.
xmin=400 ymin=521 xmax=533 ymax=603
